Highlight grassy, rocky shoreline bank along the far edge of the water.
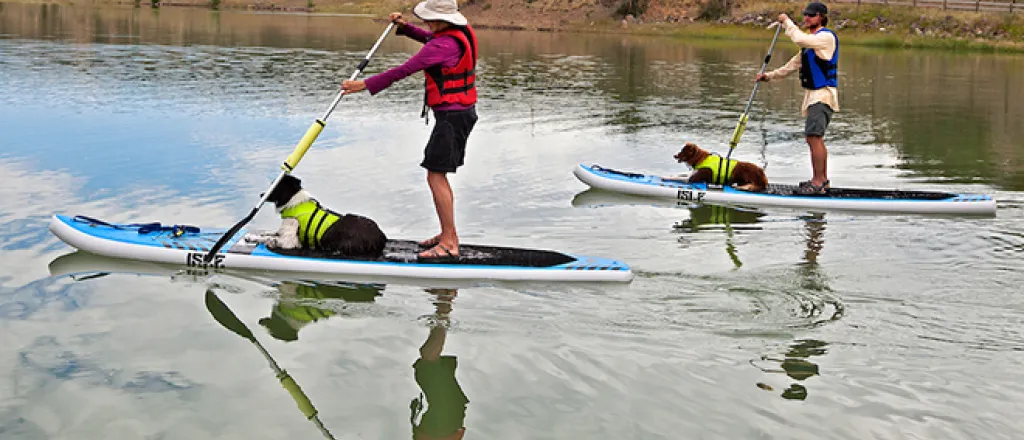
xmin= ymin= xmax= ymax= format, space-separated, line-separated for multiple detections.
xmin=4 ymin=0 xmax=1024 ymax=53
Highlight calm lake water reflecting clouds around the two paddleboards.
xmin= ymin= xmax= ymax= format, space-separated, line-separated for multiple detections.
xmin=0 ymin=3 xmax=1024 ymax=439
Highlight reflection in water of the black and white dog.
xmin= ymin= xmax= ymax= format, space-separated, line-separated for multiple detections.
xmin=259 ymin=281 xmax=384 ymax=342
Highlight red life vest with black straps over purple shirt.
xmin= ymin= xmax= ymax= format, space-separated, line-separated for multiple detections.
xmin=423 ymin=26 xmax=477 ymax=106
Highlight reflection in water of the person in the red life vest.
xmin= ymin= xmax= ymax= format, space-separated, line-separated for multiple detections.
xmin=409 ymin=289 xmax=469 ymax=440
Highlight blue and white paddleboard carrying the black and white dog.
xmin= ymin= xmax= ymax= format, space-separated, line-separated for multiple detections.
xmin=50 ymin=215 xmax=633 ymax=282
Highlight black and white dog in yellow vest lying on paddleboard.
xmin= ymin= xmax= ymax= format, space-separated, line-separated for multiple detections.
xmin=258 ymin=174 xmax=387 ymax=258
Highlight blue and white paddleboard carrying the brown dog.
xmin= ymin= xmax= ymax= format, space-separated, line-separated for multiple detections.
xmin=572 ymin=164 xmax=995 ymax=214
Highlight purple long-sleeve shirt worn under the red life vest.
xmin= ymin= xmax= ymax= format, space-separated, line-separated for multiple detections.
xmin=366 ymin=24 xmax=472 ymax=112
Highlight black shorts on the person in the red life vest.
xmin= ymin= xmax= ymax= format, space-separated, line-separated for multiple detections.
xmin=420 ymin=105 xmax=476 ymax=173
